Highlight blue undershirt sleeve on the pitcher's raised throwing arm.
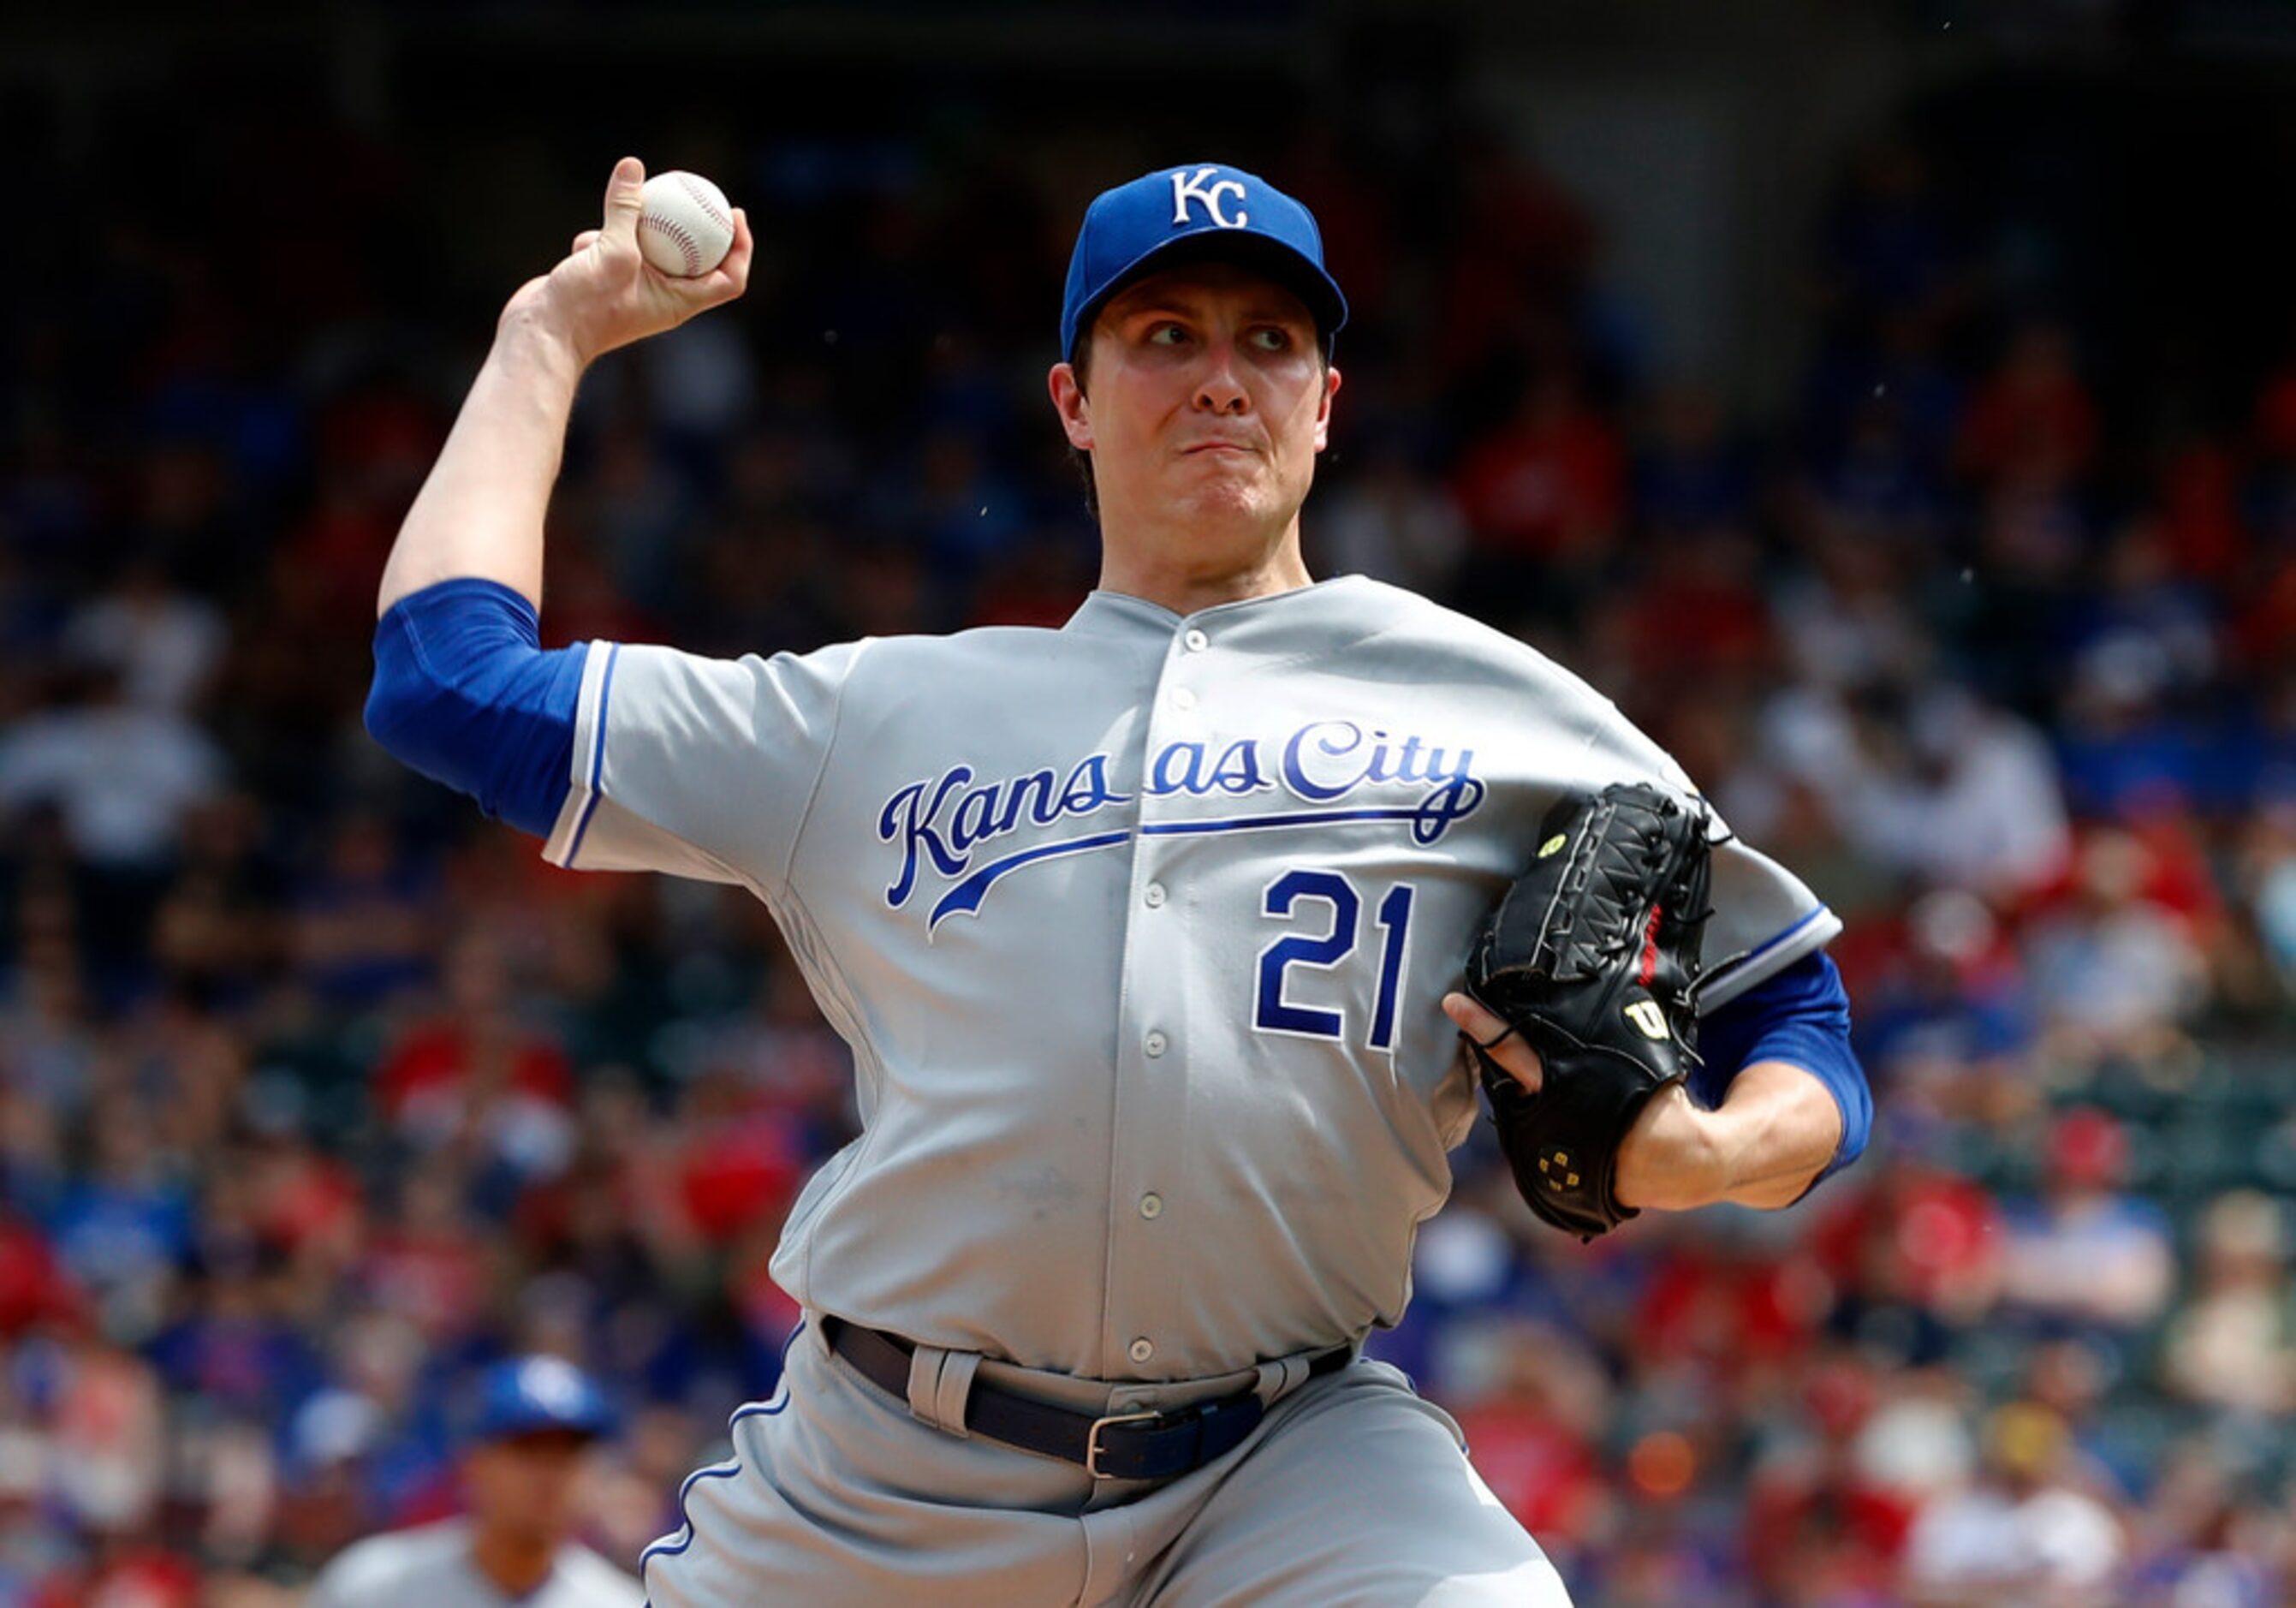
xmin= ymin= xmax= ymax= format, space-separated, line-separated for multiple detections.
xmin=367 ymin=579 xmax=588 ymax=838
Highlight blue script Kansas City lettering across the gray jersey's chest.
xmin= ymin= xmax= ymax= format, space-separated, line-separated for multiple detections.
xmin=877 ymin=721 xmax=1488 ymax=926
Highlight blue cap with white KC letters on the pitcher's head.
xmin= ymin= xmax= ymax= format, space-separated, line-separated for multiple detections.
xmin=1061 ymin=163 xmax=1347 ymax=363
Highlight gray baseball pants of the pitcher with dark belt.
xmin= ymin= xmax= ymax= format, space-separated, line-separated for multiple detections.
xmin=643 ymin=1316 xmax=1570 ymax=1608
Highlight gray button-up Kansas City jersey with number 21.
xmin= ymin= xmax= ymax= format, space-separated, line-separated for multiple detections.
xmin=544 ymin=576 xmax=1839 ymax=1380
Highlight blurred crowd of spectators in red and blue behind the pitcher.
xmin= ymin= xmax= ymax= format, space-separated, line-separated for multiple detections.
xmin=0 ymin=59 xmax=2296 ymax=1608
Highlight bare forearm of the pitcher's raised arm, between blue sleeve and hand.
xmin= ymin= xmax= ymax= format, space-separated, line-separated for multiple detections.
xmin=374 ymin=296 xmax=583 ymax=616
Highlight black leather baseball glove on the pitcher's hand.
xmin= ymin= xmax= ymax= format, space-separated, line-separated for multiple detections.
xmin=1467 ymin=783 xmax=1713 ymax=1241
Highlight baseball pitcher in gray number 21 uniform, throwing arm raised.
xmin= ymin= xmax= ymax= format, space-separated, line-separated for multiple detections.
xmin=367 ymin=158 xmax=1869 ymax=1608
